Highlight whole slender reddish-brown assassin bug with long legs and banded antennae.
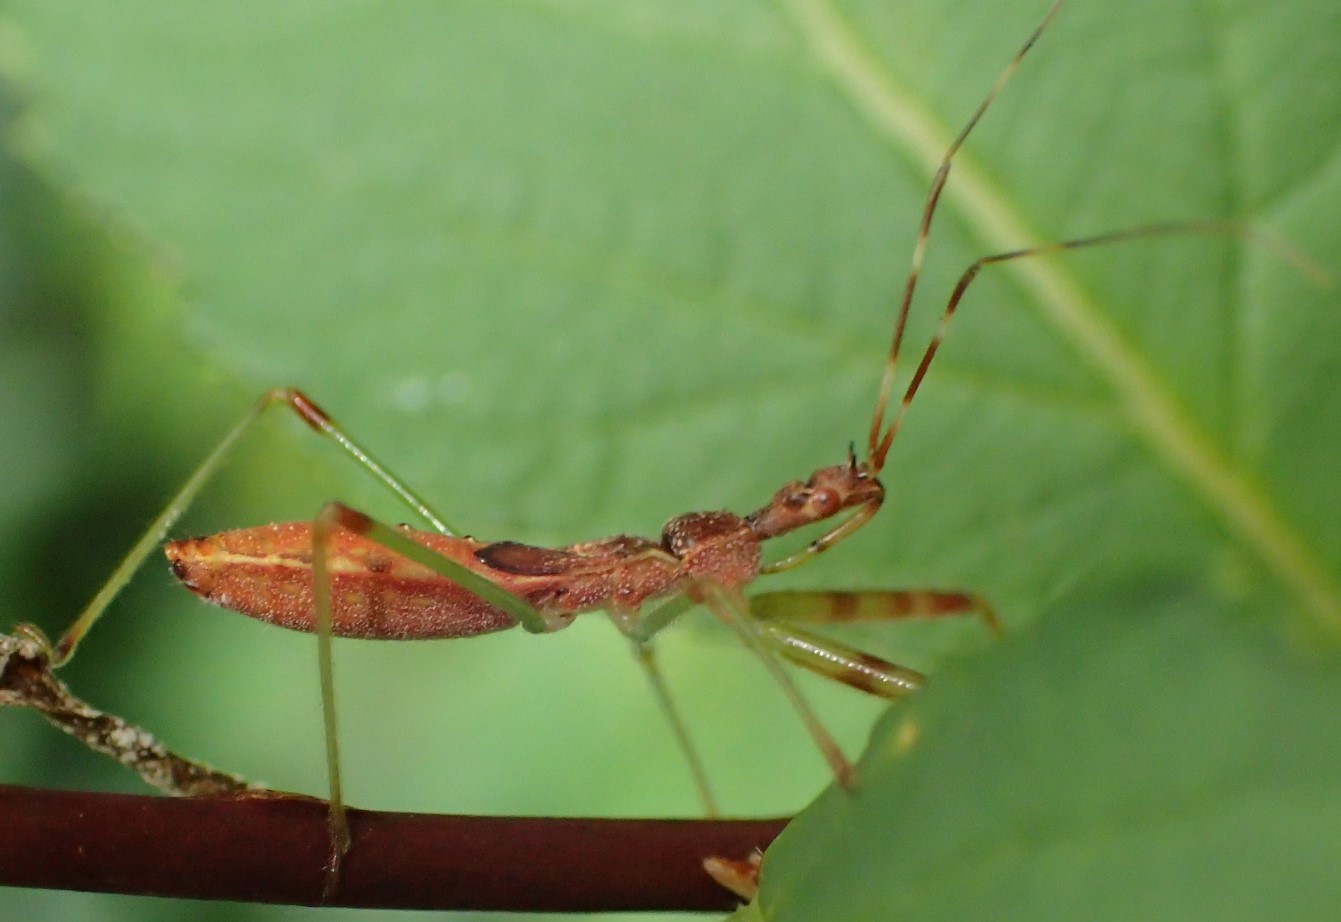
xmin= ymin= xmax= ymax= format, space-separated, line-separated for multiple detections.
xmin=10 ymin=4 xmax=1292 ymax=895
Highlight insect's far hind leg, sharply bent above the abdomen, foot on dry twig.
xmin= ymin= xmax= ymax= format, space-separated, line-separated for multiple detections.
xmin=50 ymin=387 xmax=455 ymax=666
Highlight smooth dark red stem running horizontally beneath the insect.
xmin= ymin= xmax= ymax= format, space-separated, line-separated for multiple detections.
xmin=0 ymin=785 xmax=786 ymax=913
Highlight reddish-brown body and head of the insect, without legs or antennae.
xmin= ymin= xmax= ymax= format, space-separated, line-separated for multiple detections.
xmin=165 ymin=460 xmax=884 ymax=641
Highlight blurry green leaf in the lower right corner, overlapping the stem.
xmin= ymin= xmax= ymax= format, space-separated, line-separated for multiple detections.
xmin=760 ymin=586 xmax=1341 ymax=922
